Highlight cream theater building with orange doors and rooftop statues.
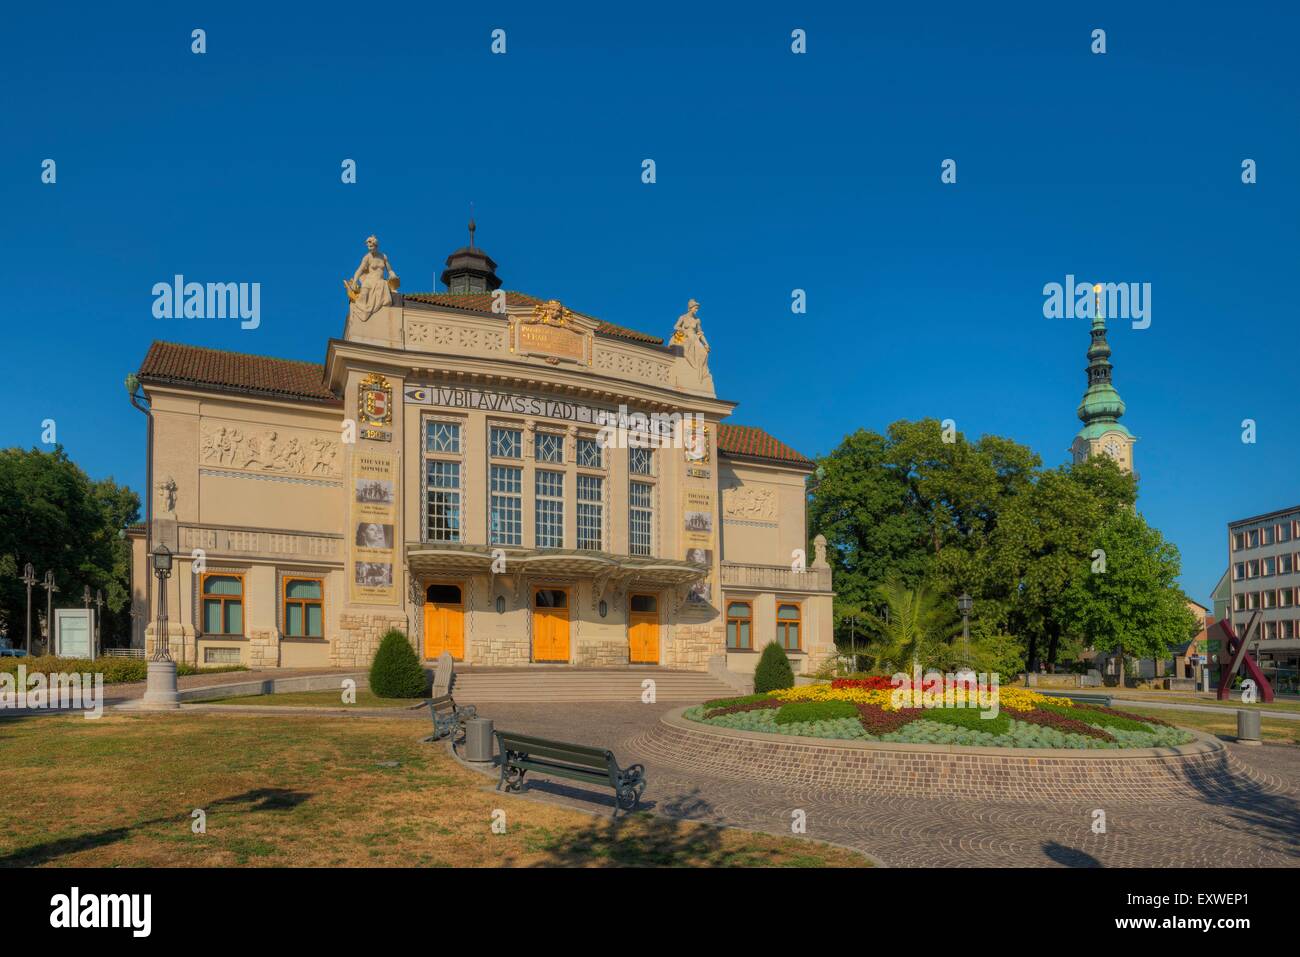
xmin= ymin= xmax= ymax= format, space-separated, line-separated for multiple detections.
xmin=131 ymin=231 xmax=833 ymax=672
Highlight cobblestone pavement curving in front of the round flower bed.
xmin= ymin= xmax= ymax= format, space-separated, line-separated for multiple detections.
xmin=480 ymin=703 xmax=1300 ymax=867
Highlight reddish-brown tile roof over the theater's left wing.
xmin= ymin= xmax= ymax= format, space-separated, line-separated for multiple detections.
xmin=139 ymin=342 xmax=339 ymax=404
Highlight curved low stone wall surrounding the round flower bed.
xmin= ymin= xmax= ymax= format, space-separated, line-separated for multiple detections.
xmin=642 ymin=707 xmax=1252 ymax=802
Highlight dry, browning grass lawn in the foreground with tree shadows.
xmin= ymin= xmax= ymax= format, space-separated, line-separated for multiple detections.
xmin=0 ymin=712 xmax=868 ymax=867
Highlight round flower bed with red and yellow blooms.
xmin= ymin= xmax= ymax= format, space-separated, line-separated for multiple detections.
xmin=683 ymin=677 xmax=1192 ymax=749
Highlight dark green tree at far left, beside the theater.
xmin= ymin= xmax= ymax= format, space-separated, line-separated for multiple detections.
xmin=0 ymin=446 xmax=140 ymax=645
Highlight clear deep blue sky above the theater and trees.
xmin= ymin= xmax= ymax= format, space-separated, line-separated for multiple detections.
xmin=0 ymin=3 xmax=1300 ymax=601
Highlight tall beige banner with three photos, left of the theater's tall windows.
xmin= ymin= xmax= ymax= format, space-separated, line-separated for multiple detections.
xmin=347 ymin=450 xmax=398 ymax=605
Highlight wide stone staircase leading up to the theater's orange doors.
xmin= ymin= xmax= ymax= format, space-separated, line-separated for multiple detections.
xmin=451 ymin=668 xmax=740 ymax=705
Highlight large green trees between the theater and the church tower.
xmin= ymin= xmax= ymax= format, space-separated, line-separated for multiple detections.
xmin=809 ymin=419 xmax=1186 ymax=674
